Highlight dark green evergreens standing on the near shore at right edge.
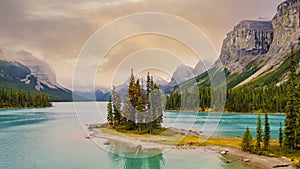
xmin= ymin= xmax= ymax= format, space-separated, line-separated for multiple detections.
xmin=241 ymin=46 xmax=300 ymax=153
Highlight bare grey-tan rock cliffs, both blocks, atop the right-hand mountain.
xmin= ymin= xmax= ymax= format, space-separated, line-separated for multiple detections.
xmin=220 ymin=0 xmax=300 ymax=76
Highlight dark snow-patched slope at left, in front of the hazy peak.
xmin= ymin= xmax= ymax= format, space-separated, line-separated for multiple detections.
xmin=0 ymin=51 xmax=72 ymax=101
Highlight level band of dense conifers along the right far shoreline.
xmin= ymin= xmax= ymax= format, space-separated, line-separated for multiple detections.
xmin=166 ymin=84 xmax=288 ymax=113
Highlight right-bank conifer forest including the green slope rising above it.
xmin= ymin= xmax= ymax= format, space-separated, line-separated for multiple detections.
xmin=166 ymin=51 xmax=300 ymax=113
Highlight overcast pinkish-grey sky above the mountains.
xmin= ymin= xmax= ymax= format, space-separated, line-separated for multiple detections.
xmin=0 ymin=0 xmax=283 ymax=87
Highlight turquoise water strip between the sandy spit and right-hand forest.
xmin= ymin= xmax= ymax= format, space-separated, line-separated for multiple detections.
xmin=164 ymin=112 xmax=285 ymax=139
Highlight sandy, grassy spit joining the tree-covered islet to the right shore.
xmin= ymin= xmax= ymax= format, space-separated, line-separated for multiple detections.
xmin=87 ymin=125 xmax=293 ymax=169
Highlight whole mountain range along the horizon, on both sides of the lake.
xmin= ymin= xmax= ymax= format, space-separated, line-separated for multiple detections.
xmin=0 ymin=0 xmax=300 ymax=101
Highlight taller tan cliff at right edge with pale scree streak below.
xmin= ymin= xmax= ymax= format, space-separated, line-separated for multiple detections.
xmin=240 ymin=0 xmax=300 ymax=85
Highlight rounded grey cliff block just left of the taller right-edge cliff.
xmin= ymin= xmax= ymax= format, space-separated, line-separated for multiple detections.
xmin=220 ymin=20 xmax=274 ymax=72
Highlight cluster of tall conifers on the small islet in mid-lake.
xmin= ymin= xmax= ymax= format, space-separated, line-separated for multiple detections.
xmin=107 ymin=71 xmax=164 ymax=133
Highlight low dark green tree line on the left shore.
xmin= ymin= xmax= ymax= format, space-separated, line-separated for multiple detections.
xmin=0 ymin=89 xmax=52 ymax=108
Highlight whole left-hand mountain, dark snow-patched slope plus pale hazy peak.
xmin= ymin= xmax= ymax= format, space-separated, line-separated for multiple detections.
xmin=0 ymin=50 xmax=72 ymax=101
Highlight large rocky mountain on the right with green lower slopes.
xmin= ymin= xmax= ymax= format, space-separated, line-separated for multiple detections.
xmin=173 ymin=0 xmax=300 ymax=88
